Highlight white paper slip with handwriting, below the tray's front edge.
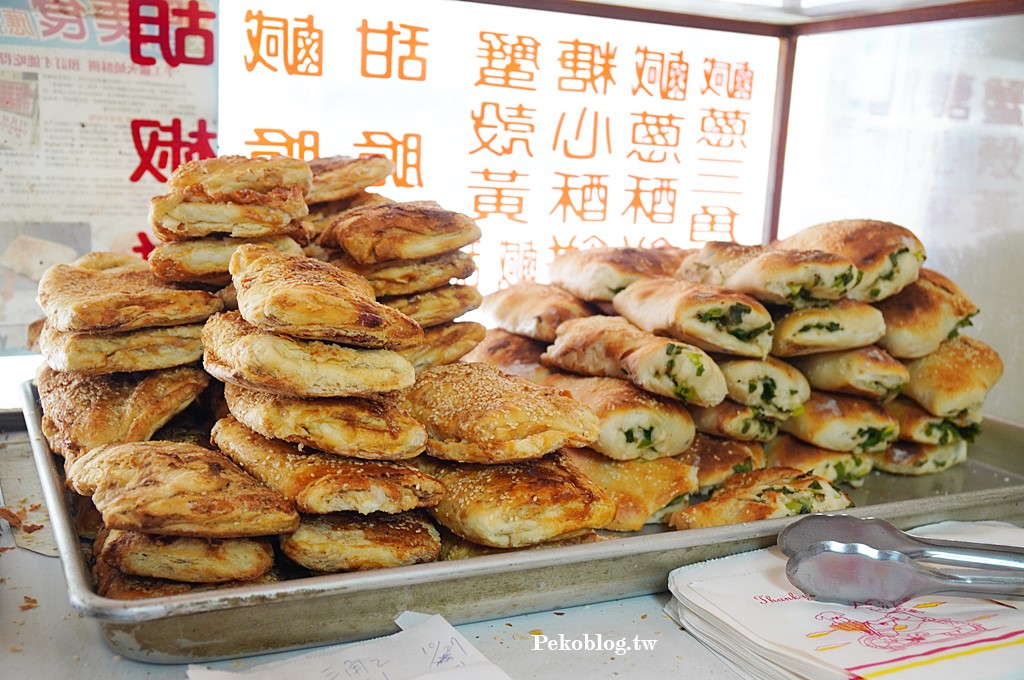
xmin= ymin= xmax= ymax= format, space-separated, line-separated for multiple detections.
xmin=188 ymin=611 xmax=511 ymax=680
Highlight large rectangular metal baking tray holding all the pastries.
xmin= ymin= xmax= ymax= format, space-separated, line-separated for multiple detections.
xmin=23 ymin=382 xmax=1024 ymax=664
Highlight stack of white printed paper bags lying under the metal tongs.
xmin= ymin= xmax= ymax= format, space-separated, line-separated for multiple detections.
xmin=666 ymin=522 xmax=1024 ymax=680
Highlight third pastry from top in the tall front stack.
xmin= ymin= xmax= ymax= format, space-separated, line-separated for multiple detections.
xmin=224 ymin=383 xmax=427 ymax=461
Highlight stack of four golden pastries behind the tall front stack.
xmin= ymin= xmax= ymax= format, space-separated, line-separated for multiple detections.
xmin=314 ymin=196 xmax=484 ymax=371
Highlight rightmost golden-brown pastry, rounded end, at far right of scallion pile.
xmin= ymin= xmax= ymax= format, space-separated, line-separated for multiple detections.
xmin=903 ymin=336 xmax=1004 ymax=418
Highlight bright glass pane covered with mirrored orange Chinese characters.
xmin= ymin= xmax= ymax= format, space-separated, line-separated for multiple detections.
xmin=219 ymin=0 xmax=778 ymax=293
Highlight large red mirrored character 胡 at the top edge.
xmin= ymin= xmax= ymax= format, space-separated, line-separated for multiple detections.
xmin=128 ymin=0 xmax=217 ymax=67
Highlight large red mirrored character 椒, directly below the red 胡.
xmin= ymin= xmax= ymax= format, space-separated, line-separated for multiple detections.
xmin=130 ymin=118 xmax=217 ymax=182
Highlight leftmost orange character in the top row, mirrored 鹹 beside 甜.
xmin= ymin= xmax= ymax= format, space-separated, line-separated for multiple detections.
xmin=246 ymin=9 xmax=324 ymax=76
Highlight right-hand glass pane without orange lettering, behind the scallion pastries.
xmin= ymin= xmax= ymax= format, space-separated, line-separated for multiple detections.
xmin=779 ymin=16 xmax=1024 ymax=421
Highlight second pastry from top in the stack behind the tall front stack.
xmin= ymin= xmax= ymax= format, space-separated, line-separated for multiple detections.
xmin=328 ymin=250 xmax=476 ymax=297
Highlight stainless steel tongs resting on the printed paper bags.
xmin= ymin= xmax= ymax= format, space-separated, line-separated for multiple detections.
xmin=778 ymin=515 xmax=1024 ymax=607
